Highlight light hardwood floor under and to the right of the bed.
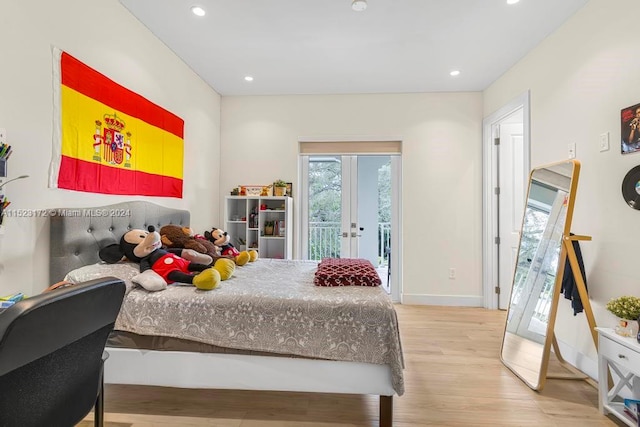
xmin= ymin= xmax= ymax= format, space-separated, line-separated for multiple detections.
xmin=80 ymin=305 xmax=624 ymax=427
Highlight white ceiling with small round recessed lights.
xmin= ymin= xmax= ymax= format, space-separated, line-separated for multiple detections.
xmin=120 ymin=0 xmax=588 ymax=96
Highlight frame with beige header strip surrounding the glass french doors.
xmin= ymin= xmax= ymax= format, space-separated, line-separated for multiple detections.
xmin=294 ymin=136 xmax=403 ymax=303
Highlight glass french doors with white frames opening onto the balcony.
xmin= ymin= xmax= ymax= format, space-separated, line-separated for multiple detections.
xmin=301 ymin=155 xmax=400 ymax=298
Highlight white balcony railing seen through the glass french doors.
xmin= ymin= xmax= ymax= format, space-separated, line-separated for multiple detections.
xmin=309 ymin=222 xmax=391 ymax=267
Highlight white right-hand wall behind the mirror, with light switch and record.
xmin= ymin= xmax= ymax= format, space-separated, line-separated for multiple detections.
xmin=484 ymin=0 xmax=640 ymax=370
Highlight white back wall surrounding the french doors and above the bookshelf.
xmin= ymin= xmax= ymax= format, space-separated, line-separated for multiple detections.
xmin=220 ymin=93 xmax=482 ymax=305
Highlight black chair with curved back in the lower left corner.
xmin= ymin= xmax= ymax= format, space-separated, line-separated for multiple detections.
xmin=0 ymin=277 xmax=125 ymax=427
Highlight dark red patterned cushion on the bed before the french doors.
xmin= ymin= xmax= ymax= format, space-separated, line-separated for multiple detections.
xmin=313 ymin=258 xmax=382 ymax=286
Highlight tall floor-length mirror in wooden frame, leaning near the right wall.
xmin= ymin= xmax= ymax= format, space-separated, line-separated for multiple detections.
xmin=501 ymin=160 xmax=580 ymax=390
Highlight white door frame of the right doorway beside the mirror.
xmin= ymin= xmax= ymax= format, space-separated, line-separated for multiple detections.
xmin=482 ymin=91 xmax=531 ymax=310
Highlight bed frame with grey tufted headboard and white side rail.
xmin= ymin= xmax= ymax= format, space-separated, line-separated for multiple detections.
xmin=50 ymin=202 xmax=395 ymax=427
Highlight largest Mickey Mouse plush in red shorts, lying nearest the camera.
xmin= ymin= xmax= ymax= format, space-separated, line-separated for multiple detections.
xmin=99 ymin=225 xmax=220 ymax=290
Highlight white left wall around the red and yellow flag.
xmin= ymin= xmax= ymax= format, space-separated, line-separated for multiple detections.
xmin=0 ymin=0 xmax=220 ymax=295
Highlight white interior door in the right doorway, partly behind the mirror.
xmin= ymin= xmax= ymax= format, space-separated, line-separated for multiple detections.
xmin=497 ymin=110 xmax=528 ymax=309
